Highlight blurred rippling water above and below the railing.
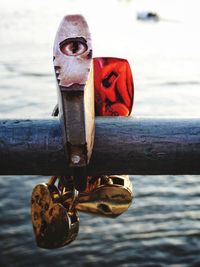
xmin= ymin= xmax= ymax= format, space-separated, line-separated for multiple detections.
xmin=0 ymin=0 xmax=200 ymax=267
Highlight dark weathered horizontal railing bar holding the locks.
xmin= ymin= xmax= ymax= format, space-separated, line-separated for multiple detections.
xmin=0 ymin=117 xmax=200 ymax=175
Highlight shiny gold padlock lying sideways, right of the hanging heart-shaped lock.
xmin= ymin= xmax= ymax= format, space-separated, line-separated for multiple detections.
xmin=63 ymin=175 xmax=133 ymax=218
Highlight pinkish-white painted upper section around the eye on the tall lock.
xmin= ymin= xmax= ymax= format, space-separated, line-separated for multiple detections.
xmin=53 ymin=15 xmax=92 ymax=87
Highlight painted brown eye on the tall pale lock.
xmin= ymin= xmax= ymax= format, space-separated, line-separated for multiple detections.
xmin=60 ymin=37 xmax=88 ymax=56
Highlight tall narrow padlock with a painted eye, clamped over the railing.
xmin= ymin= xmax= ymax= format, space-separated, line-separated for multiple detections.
xmin=53 ymin=15 xmax=95 ymax=191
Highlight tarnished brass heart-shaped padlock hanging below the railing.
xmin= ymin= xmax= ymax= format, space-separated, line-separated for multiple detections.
xmin=31 ymin=177 xmax=79 ymax=249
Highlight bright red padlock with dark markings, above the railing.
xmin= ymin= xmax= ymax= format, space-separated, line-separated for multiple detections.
xmin=93 ymin=57 xmax=134 ymax=116
